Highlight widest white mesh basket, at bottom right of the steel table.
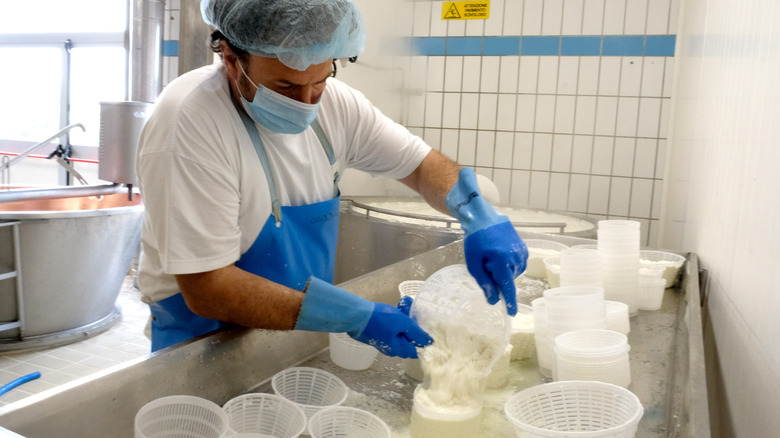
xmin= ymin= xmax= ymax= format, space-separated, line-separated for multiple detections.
xmin=504 ymin=380 xmax=644 ymax=438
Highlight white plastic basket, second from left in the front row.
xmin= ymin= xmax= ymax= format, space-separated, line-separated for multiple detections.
xmin=222 ymin=393 xmax=306 ymax=438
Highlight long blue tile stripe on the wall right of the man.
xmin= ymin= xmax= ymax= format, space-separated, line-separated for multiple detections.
xmin=407 ymin=35 xmax=676 ymax=56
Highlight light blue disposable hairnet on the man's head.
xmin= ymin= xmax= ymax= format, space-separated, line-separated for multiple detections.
xmin=200 ymin=0 xmax=366 ymax=70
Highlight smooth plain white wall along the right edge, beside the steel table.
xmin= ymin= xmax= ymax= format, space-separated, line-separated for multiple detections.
xmin=660 ymin=0 xmax=780 ymax=438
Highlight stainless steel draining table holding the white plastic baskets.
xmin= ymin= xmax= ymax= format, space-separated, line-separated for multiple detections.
xmin=0 ymin=236 xmax=709 ymax=438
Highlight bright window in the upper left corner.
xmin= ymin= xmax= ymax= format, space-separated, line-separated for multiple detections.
xmin=0 ymin=0 xmax=128 ymax=149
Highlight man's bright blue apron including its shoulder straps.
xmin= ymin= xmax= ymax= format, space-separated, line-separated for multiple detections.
xmin=149 ymin=108 xmax=340 ymax=351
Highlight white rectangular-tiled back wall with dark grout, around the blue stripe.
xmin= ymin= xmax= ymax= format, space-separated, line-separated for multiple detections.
xmin=339 ymin=0 xmax=678 ymax=245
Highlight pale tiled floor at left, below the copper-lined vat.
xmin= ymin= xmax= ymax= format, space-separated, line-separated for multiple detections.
xmin=0 ymin=277 xmax=151 ymax=408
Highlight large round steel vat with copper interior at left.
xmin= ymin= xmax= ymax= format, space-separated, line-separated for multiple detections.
xmin=0 ymin=193 xmax=144 ymax=352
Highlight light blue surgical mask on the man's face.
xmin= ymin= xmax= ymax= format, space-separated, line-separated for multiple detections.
xmin=238 ymin=62 xmax=320 ymax=134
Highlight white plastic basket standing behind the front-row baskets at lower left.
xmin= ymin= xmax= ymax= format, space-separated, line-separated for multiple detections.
xmin=271 ymin=367 xmax=349 ymax=418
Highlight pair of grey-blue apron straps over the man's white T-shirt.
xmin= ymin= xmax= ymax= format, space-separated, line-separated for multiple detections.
xmin=231 ymin=99 xmax=341 ymax=227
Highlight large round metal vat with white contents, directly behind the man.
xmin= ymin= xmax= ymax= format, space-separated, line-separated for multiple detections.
xmin=335 ymin=197 xmax=597 ymax=282
